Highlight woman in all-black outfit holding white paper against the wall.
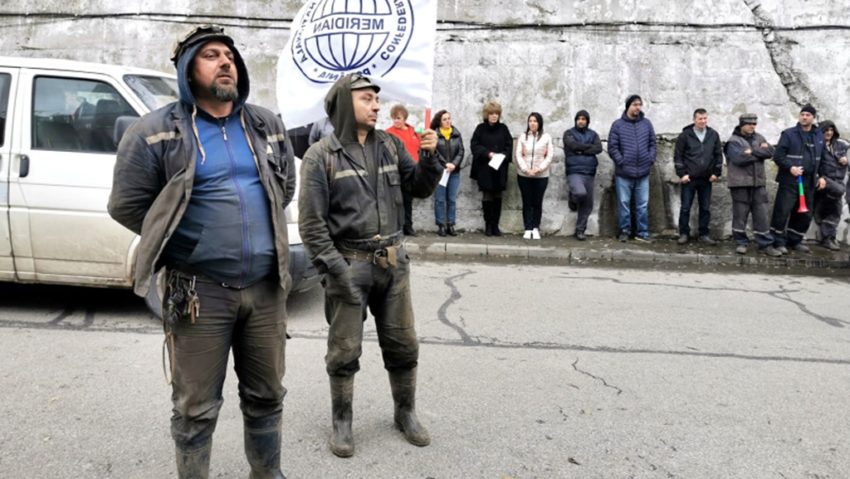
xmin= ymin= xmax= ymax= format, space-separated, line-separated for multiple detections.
xmin=469 ymin=101 xmax=514 ymax=236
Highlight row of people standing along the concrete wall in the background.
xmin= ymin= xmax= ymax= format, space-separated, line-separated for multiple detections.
xmin=387 ymin=95 xmax=850 ymax=257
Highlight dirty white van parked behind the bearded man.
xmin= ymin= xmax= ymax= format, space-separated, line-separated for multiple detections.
xmin=0 ymin=57 xmax=320 ymax=302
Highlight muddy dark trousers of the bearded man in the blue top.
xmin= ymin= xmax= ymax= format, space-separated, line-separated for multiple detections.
xmin=164 ymin=272 xmax=286 ymax=449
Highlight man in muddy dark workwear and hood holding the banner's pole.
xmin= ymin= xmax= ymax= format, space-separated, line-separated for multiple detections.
xmin=298 ymin=74 xmax=443 ymax=457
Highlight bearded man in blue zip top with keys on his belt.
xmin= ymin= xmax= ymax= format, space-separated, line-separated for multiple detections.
xmin=109 ymin=26 xmax=295 ymax=478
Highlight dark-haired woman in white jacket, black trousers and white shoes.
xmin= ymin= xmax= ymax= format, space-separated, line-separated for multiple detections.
xmin=514 ymin=112 xmax=555 ymax=239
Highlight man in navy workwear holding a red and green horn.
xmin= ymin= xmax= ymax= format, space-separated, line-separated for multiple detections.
xmin=770 ymin=105 xmax=826 ymax=254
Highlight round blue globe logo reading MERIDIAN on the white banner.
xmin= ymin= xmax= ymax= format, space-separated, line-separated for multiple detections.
xmin=291 ymin=0 xmax=414 ymax=83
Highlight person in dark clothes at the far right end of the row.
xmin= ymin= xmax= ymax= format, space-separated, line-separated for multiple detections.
xmin=814 ymin=120 xmax=850 ymax=251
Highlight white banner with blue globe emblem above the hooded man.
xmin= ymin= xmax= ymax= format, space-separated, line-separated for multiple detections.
xmin=277 ymin=0 xmax=437 ymax=128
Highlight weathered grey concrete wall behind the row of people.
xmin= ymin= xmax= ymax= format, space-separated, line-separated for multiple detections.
xmin=0 ymin=0 xmax=850 ymax=241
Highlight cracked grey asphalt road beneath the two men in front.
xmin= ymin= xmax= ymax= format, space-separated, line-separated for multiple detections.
xmin=0 ymin=262 xmax=850 ymax=479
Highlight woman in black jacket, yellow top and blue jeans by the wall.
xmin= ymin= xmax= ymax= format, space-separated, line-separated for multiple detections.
xmin=431 ymin=110 xmax=465 ymax=236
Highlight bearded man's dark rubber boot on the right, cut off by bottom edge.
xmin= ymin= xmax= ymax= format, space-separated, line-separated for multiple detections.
xmin=243 ymin=414 xmax=285 ymax=479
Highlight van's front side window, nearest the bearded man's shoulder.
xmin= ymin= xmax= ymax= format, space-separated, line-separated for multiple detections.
xmin=32 ymin=76 xmax=139 ymax=153
